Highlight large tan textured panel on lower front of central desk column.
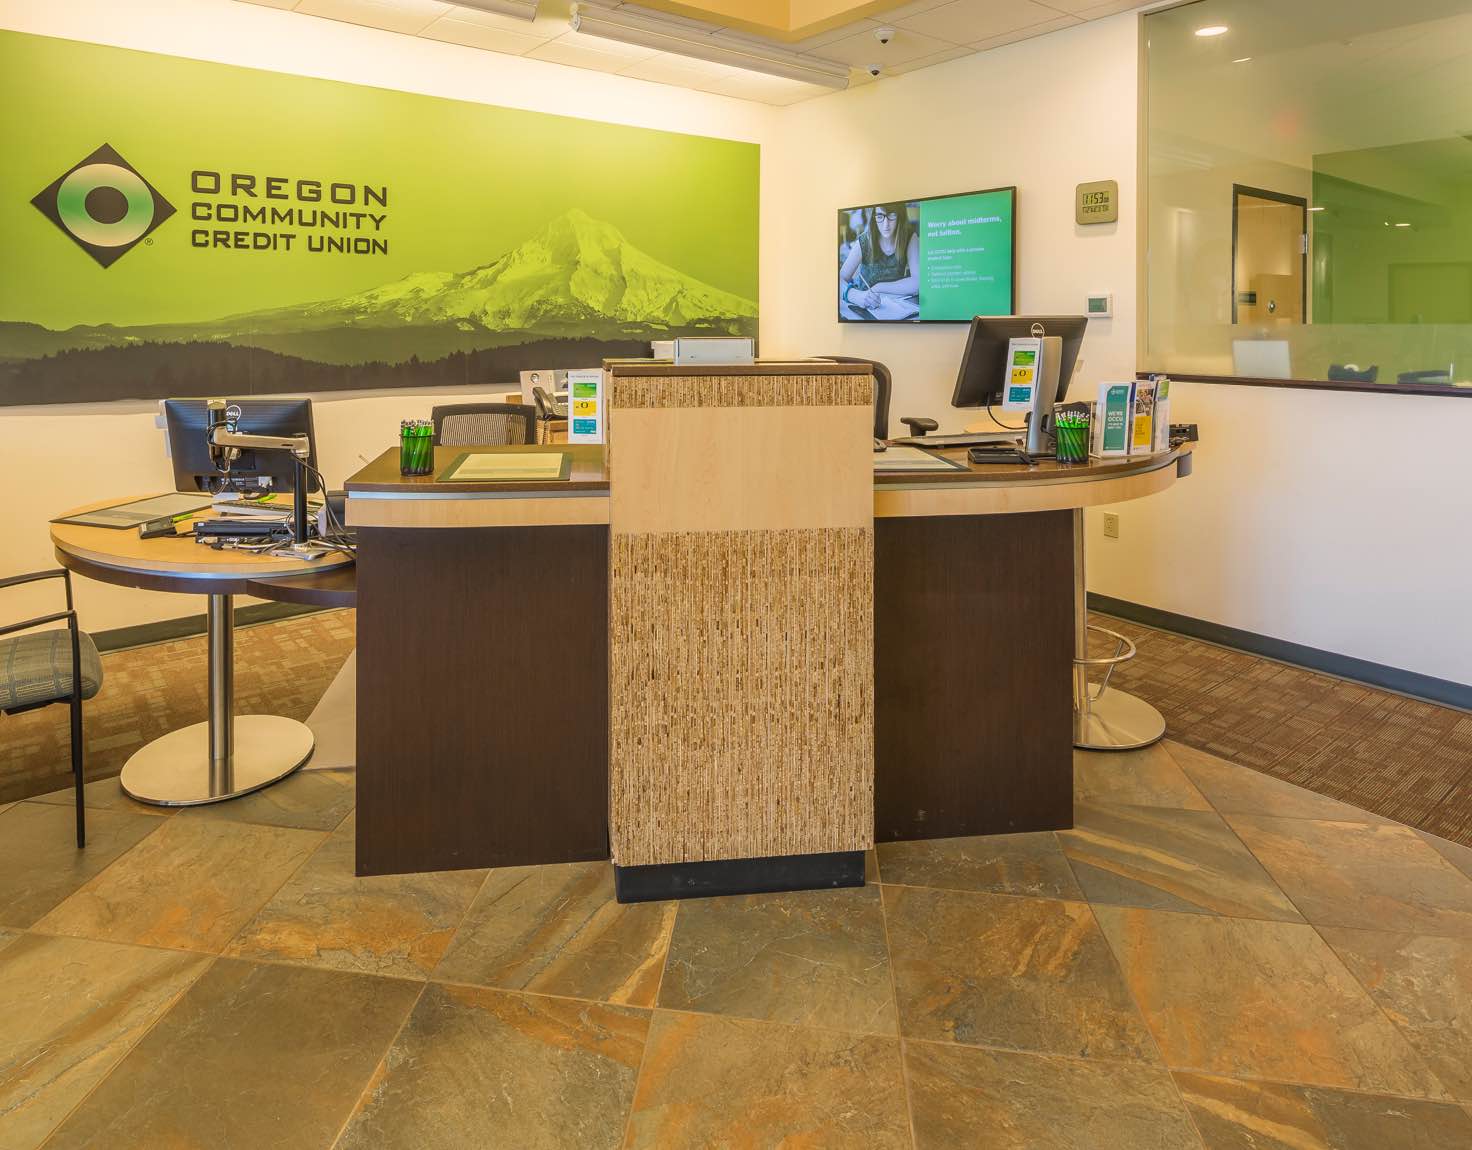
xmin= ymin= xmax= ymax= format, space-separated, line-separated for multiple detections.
xmin=609 ymin=527 xmax=874 ymax=866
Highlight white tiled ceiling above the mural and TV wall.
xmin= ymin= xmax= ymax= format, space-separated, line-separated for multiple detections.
xmin=241 ymin=0 xmax=1158 ymax=105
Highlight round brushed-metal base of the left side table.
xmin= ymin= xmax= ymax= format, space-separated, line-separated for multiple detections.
xmin=121 ymin=714 xmax=312 ymax=807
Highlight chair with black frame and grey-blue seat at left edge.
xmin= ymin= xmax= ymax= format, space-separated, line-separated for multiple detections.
xmin=0 ymin=570 xmax=102 ymax=847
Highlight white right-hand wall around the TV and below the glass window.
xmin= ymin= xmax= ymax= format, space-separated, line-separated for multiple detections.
xmin=762 ymin=15 xmax=1472 ymax=683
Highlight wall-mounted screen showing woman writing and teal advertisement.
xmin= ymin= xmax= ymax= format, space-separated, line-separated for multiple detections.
xmin=838 ymin=187 xmax=1017 ymax=324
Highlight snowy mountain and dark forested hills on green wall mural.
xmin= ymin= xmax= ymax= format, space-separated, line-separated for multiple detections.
xmin=0 ymin=208 xmax=757 ymax=403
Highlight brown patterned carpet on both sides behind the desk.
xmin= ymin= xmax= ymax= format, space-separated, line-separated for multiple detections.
xmin=0 ymin=611 xmax=1472 ymax=845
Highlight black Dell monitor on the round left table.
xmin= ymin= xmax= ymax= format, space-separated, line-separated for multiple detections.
xmin=163 ymin=399 xmax=321 ymax=492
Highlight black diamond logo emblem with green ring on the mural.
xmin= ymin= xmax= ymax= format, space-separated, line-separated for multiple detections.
xmin=31 ymin=144 xmax=174 ymax=268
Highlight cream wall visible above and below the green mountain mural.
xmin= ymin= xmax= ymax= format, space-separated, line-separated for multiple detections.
xmin=0 ymin=0 xmax=780 ymax=630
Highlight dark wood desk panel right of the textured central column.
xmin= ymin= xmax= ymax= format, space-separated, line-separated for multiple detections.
xmin=874 ymin=511 xmax=1073 ymax=842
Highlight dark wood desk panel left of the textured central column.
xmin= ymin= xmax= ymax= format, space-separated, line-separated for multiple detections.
xmin=358 ymin=526 xmax=608 ymax=875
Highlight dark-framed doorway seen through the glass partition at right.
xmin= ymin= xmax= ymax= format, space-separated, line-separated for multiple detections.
xmin=1232 ymin=184 xmax=1309 ymax=327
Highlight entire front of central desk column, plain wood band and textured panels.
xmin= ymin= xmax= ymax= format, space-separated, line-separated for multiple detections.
xmin=609 ymin=365 xmax=874 ymax=867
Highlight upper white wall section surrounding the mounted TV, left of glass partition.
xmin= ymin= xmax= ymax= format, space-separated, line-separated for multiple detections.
xmin=761 ymin=16 xmax=1138 ymax=434
